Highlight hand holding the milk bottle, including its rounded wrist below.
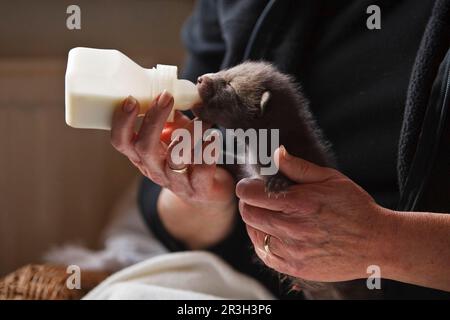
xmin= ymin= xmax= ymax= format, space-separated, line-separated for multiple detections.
xmin=111 ymin=92 xmax=236 ymax=248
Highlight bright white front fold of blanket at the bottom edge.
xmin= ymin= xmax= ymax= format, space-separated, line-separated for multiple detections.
xmin=84 ymin=251 xmax=273 ymax=300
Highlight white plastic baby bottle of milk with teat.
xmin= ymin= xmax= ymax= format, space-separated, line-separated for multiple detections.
xmin=65 ymin=48 xmax=200 ymax=130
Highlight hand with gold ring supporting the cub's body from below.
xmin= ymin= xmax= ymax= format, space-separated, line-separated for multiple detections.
xmin=236 ymin=147 xmax=384 ymax=282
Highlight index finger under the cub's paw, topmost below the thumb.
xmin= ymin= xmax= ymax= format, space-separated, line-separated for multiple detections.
xmin=236 ymin=178 xmax=316 ymax=213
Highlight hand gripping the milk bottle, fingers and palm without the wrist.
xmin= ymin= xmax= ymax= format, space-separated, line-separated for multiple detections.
xmin=111 ymin=92 xmax=234 ymax=208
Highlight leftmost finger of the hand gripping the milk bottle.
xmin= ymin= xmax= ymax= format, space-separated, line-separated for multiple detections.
xmin=111 ymin=96 xmax=139 ymax=162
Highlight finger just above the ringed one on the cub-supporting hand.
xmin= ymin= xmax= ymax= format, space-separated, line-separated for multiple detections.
xmin=239 ymin=200 xmax=293 ymax=238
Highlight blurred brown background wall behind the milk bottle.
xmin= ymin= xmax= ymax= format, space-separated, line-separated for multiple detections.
xmin=0 ymin=0 xmax=194 ymax=276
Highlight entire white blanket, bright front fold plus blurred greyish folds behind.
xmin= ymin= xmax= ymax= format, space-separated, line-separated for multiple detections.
xmin=45 ymin=182 xmax=273 ymax=299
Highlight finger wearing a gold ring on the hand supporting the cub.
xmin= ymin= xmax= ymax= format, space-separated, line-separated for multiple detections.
xmin=246 ymin=225 xmax=289 ymax=262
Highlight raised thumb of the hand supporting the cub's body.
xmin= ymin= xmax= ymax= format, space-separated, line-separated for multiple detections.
xmin=274 ymin=146 xmax=336 ymax=183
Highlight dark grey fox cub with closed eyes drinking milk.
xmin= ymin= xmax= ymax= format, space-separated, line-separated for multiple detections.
xmin=193 ymin=62 xmax=334 ymax=298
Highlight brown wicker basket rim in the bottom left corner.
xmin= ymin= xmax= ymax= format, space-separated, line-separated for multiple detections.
xmin=0 ymin=264 xmax=109 ymax=300
